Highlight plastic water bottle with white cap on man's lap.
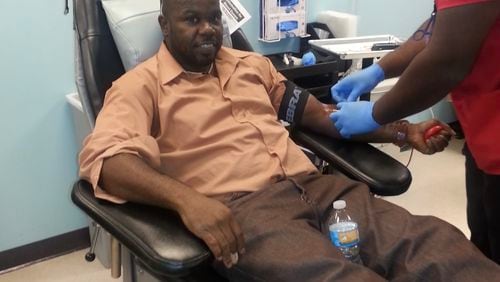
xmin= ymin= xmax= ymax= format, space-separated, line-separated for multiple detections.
xmin=328 ymin=200 xmax=363 ymax=264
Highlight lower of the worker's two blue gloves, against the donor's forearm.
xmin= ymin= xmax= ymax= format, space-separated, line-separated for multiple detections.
xmin=330 ymin=101 xmax=380 ymax=138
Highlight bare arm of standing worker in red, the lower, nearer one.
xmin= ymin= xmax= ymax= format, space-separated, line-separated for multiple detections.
xmin=373 ymin=0 xmax=500 ymax=124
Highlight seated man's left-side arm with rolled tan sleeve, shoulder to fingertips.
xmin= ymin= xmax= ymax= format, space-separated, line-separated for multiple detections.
xmin=80 ymin=79 xmax=243 ymax=265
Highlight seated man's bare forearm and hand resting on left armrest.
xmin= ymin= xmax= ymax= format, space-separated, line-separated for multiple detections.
xmin=100 ymin=153 xmax=244 ymax=267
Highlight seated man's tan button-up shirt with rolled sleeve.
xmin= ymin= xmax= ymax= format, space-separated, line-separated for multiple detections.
xmin=80 ymin=44 xmax=317 ymax=202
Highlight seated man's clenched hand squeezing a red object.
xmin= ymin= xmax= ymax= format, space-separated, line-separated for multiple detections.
xmin=407 ymin=119 xmax=455 ymax=155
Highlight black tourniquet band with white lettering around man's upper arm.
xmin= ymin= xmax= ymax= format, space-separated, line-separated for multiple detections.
xmin=278 ymin=80 xmax=310 ymax=124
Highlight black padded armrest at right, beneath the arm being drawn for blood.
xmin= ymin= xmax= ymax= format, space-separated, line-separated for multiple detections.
xmin=291 ymin=128 xmax=411 ymax=196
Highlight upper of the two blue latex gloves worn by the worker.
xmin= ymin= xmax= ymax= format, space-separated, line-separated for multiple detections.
xmin=330 ymin=64 xmax=385 ymax=102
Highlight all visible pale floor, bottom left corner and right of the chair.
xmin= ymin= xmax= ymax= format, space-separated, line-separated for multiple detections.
xmin=0 ymin=140 xmax=469 ymax=282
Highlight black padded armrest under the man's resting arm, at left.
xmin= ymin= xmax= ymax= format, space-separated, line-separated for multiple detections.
xmin=71 ymin=180 xmax=223 ymax=281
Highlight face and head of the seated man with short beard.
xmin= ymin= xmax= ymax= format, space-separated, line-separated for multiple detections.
xmin=159 ymin=0 xmax=222 ymax=71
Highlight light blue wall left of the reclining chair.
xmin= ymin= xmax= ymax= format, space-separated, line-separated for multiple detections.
xmin=0 ymin=0 xmax=85 ymax=251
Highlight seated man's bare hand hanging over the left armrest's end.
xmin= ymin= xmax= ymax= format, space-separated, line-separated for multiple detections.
xmin=179 ymin=194 xmax=245 ymax=268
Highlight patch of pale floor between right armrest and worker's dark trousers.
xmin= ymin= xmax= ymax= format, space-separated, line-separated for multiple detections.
xmin=380 ymin=140 xmax=470 ymax=237
